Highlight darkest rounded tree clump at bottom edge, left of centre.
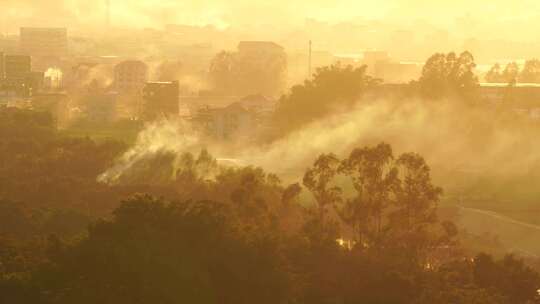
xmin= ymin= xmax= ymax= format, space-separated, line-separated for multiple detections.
xmin=35 ymin=196 xmax=290 ymax=303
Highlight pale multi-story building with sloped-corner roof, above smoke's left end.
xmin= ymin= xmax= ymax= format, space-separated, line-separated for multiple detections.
xmin=114 ymin=60 xmax=148 ymax=94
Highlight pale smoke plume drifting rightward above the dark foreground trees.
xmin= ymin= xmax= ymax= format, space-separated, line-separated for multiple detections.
xmin=99 ymin=97 xmax=540 ymax=186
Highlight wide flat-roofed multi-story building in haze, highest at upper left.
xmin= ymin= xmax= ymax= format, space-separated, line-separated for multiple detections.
xmin=20 ymin=27 xmax=68 ymax=57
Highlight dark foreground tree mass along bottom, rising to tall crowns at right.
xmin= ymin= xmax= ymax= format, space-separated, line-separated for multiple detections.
xmin=0 ymin=139 xmax=540 ymax=303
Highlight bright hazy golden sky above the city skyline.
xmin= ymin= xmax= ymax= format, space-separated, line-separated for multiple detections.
xmin=0 ymin=0 xmax=540 ymax=37
